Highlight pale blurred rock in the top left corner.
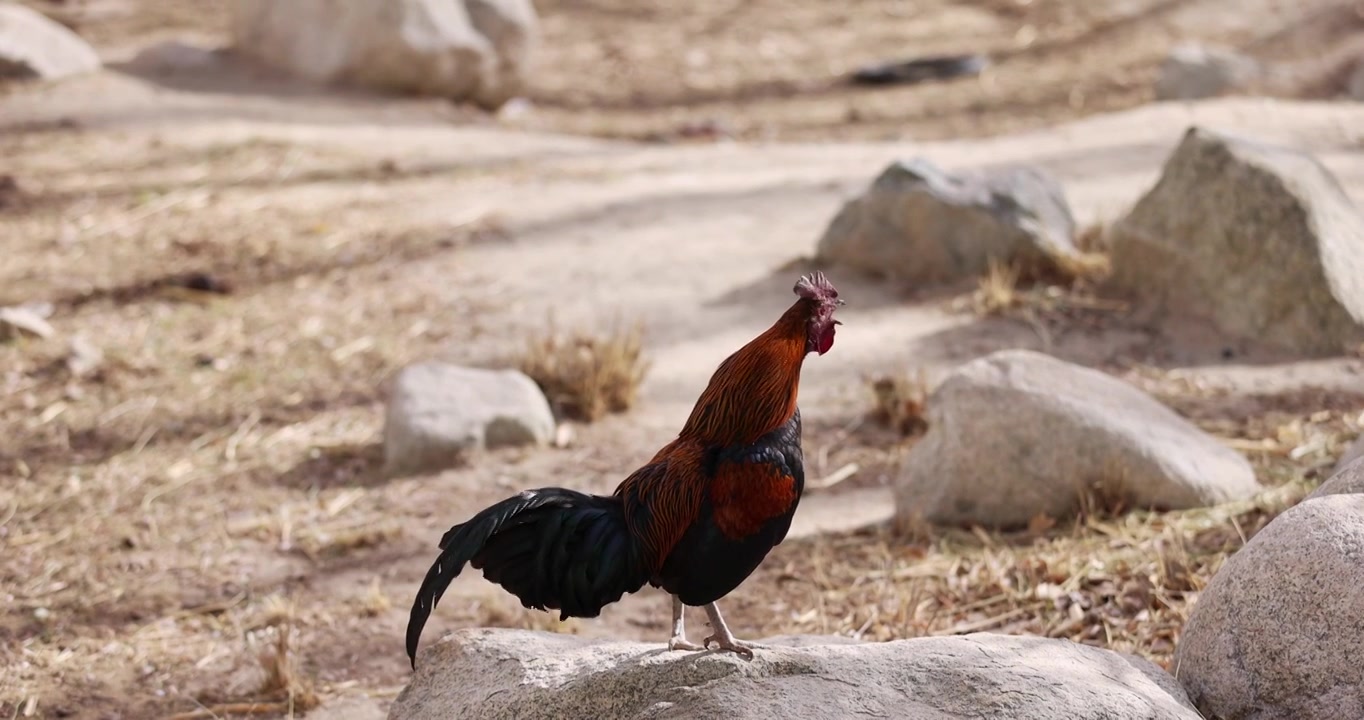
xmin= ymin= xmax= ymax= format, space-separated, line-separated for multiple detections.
xmin=0 ymin=3 xmax=101 ymax=80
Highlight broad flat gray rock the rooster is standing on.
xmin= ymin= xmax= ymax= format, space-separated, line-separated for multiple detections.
xmin=389 ymin=630 xmax=1198 ymax=720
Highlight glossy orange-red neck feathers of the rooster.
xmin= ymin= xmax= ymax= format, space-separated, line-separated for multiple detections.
xmin=681 ymin=300 xmax=813 ymax=446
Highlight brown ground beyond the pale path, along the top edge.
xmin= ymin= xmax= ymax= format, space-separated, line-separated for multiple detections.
xmin=26 ymin=0 xmax=1364 ymax=140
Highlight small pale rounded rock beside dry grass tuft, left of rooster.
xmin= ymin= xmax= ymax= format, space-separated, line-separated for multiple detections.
xmin=383 ymin=361 xmax=554 ymax=475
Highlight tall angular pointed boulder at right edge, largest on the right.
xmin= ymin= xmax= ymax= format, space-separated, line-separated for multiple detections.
xmin=1109 ymin=127 xmax=1364 ymax=356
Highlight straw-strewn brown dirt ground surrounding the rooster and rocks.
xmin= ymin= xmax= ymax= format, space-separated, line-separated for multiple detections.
xmin=8 ymin=0 xmax=1364 ymax=719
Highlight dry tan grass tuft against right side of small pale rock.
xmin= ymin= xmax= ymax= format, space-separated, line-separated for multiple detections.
xmin=517 ymin=319 xmax=649 ymax=423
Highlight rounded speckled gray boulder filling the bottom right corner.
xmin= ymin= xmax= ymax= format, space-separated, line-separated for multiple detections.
xmin=1174 ymin=495 xmax=1364 ymax=720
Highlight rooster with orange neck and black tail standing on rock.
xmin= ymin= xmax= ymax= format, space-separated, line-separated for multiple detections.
xmin=406 ymin=273 xmax=843 ymax=668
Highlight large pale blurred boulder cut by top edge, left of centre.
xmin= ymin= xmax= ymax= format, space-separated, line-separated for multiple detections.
xmin=232 ymin=0 xmax=539 ymax=109
